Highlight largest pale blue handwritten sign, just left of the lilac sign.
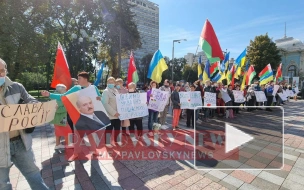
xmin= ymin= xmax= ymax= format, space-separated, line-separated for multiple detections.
xmin=116 ymin=93 xmax=149 ymax=120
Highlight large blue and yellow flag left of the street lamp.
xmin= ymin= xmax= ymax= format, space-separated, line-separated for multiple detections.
xmin=148 ymin=50 xmax=168 ymax=83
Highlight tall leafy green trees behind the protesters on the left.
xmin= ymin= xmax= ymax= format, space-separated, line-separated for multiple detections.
xmin=0 ymin=0 xmax=141 ymax=83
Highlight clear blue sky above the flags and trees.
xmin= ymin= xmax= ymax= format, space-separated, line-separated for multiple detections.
xmin=150 ymin=0 xmax=304 ymax=59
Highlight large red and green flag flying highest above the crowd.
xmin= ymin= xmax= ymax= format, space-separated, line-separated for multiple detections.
xmin=199 ymin=19 xmax=224 ymax=63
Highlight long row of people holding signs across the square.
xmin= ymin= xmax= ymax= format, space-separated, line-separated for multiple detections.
xmin=0 ymin=55 xmax=297 ymax=189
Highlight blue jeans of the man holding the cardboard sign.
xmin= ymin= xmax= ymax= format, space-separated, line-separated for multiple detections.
xmin=0 ymin=139 xmax=49 ymax=190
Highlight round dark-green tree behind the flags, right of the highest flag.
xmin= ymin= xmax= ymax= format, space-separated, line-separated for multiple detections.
xmin=247 ymin=33 xmax=281 ymax=74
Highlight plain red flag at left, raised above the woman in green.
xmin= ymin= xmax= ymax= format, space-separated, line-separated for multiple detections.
xmin=51 ymin=42 xmax=72 ymax=89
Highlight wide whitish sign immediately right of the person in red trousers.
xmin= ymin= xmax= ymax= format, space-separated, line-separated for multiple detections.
xmin=179 ymin=91 xmax=203 ymax=109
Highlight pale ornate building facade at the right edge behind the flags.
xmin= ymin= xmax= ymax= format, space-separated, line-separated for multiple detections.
xmin=275 ymin=36 xmax=304 ymax=84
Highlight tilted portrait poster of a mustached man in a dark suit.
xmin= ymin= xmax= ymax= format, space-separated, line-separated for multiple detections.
xmin=58 ymin=85 xmax=111 ymax=132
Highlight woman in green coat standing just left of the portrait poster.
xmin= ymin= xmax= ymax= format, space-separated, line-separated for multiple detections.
xmin=50 ymin=84 xmax=72 ymax=150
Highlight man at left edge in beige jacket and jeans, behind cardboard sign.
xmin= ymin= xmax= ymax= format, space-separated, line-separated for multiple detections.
xmin=0 ymin=58 xmax=49 ymax=190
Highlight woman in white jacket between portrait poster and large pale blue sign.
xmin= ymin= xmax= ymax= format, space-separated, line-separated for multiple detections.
xmin=101 ymin=77 xmax=120 ymax=146
